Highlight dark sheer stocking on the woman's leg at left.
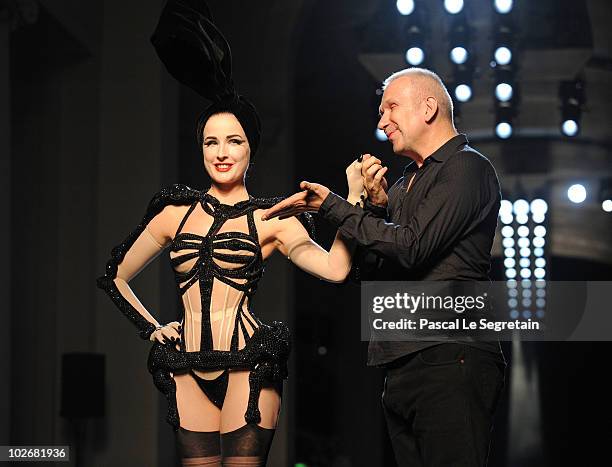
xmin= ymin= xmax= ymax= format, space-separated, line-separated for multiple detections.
xmin=176 ymin=427 xmax=221 ymax=467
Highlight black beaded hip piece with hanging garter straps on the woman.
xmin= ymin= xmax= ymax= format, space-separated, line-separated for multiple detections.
xmin=148 ymin=321 xmax=291 ymax=431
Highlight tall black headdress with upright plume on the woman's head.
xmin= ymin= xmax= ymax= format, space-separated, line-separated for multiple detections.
xmin=151 ymin=0 xmax=261 ymax=160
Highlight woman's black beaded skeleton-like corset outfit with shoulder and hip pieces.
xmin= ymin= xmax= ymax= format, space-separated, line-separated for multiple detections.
xmin=98 ymin=185 xmax=312 ymax=430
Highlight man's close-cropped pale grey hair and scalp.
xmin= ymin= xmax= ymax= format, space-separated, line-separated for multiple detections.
xmin=382 ymin=67 xmax=454 ymax=127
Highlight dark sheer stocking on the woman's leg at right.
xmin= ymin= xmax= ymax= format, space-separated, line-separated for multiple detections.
xmin=221 ymin=423 xmax=275 ymax=467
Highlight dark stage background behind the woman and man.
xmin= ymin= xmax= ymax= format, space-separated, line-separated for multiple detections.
xmin=0 ymin=0 xmax=612 ymax=467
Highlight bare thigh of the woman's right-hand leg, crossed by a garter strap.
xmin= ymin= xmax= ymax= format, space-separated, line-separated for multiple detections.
xmin=221 ymin=370 xmax=281 ymax=433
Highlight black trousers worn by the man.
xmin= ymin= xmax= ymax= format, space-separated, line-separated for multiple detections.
xmin=382 ymin=343 xmax=506 ymax=467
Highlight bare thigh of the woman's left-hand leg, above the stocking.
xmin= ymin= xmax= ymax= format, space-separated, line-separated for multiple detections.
xmin=174 ymin=373 xmax=221 ymax=431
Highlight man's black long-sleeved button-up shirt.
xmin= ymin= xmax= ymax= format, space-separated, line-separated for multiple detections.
xmin=319 ymin=135 xmax=501 ymax=365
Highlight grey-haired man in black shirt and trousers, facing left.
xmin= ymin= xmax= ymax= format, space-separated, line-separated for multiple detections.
xmin=264 ymin=68 xmax=505 ymax=467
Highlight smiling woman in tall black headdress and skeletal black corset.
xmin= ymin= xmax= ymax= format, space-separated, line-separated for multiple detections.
xmin=98 ymin=0 xmax=363 ymax=466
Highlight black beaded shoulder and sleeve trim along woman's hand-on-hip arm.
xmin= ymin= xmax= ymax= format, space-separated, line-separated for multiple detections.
xmin=97 ymin=184 xmax=200 ymax=339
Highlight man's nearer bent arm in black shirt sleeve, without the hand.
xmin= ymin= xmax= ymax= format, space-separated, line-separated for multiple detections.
xmin=319 ymin=153 xmax=499 ymax=269
